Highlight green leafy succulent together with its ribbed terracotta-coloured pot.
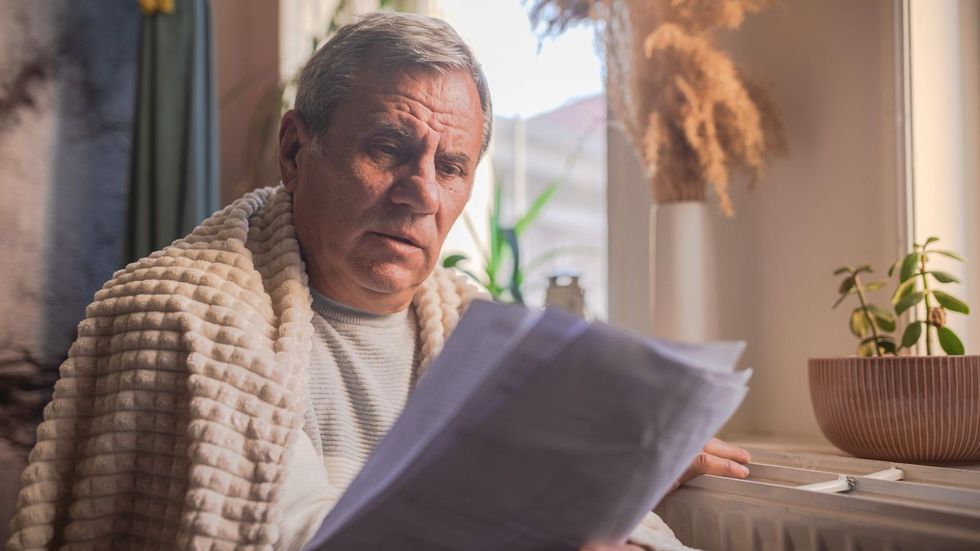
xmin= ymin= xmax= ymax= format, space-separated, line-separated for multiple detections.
xmin=809 ymin=237 xmax=980 ymax=463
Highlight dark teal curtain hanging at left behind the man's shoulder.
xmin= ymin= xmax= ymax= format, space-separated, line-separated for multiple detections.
xmin=125 ymin=0 xmax=219 ymax=261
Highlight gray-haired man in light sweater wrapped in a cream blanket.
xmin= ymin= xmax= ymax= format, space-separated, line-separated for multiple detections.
xmin=8 ymin=9 xmax=747 ymax=550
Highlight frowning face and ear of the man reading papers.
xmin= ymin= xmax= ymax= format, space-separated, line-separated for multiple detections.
xmin=280 ymin=64 xmax=483 ymax=312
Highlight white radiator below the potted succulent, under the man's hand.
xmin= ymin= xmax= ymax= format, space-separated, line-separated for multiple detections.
xmin=657 ymin=448 xmax=980 ymax=551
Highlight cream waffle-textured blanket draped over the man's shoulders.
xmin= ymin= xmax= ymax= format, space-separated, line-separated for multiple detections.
xmin=7 ymin=186 xmax=473 ymax=550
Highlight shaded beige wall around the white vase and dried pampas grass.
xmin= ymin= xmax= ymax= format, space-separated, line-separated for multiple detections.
xmin=609 ymin=0 xmax=901 ymax=441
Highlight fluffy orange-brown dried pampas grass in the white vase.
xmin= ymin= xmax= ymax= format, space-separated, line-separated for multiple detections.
xmin=529 ymin=0 xmax=786 ymax=216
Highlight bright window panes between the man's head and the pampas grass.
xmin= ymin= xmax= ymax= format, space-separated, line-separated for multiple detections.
xmin=440 ymin=0 xmax=607 ymax=318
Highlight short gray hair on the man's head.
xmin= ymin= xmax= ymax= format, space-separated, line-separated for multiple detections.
xmin=296 ymin=12 xmax=493 ymax=156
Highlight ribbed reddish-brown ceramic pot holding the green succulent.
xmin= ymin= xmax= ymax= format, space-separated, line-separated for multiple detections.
xmin=809 ymin=356 xmax=980 ymax=463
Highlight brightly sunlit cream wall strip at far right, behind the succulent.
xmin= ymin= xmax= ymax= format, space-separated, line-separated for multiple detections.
xmin=909 ymin=0 xmax=980 ymax=354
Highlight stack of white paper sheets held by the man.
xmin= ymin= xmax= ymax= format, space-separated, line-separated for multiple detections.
xmin=306 ymin=301 xmax=750 ymax=551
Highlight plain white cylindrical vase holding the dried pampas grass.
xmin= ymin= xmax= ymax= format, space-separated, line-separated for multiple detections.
xmin=650 ymin=201 xmax=718 ymax=342
